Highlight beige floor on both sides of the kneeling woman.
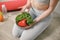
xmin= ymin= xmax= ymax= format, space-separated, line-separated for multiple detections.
xmin=0 ymin=0 xmax=60 ymax=40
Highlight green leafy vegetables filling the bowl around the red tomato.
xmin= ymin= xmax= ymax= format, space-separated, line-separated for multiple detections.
xmin=16 ymin=12 xmax=33 ymax=25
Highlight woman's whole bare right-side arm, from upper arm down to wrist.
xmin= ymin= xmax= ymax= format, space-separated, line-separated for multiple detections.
xmin=35 ymin=0 xmax=58 ymax=22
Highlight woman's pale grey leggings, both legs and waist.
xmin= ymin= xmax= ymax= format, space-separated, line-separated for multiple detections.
xmin=12 ymin=9 xmax=52 ymax=40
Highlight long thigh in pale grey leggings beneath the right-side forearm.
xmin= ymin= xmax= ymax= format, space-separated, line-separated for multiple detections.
xmin=20 ymin=14 xmax=51 ymax=40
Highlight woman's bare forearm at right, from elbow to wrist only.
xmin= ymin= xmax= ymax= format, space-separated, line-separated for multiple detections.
xmin=34 ymin=8 xmax=53 ymax=22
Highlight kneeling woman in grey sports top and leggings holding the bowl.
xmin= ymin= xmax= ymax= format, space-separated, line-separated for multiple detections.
xmin=12 ymin=0 xmax=58 ymax=40
